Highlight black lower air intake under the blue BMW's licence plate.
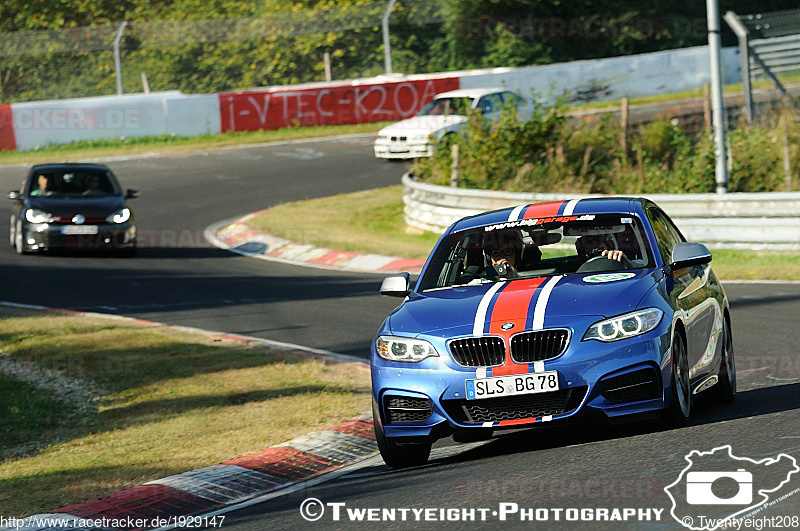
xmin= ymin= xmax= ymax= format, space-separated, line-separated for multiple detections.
xmin=442 ymin=386 xmax=587 ymax=424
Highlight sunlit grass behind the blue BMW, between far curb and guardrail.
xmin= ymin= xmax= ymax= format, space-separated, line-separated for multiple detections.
xmin=247 ymin=185 xmax=800 ymax=281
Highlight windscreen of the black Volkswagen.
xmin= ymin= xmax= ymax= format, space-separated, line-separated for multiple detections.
xmin=27 ymin=168 xmax=122 ymax=199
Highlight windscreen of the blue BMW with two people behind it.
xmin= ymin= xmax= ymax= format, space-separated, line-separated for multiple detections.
xmin=420 ymin=214 xmax=654 ymax=291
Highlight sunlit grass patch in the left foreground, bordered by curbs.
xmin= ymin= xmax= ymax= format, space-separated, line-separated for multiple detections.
xmin=0 ymin=308 xmax=370 ymax=517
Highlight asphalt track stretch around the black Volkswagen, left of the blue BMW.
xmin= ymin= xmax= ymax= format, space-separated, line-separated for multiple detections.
xmin=0 ymin=135 xmax=404 ymax=356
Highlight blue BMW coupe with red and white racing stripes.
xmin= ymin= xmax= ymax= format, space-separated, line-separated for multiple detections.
xmin=370 ymin=197 xmax=736 ymax=468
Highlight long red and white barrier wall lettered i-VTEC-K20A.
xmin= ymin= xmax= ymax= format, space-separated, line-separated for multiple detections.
xmin=0 ymin=47 xmax=741 ymax=151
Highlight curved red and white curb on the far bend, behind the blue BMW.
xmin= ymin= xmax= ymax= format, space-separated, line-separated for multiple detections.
xmin=205 ymin=215 xmax=425 ymax=273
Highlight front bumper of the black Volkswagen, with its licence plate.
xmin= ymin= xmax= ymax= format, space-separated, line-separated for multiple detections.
xmin=22 ymin=223 xmax=136 ymax=251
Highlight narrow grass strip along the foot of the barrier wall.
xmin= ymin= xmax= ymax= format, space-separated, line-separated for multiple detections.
xmin=0 ymin=122 xmax=389 ymax=165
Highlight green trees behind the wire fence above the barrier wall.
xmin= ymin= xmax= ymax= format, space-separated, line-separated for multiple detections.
xmin=0 ymin=0 xmax=796 ymax=103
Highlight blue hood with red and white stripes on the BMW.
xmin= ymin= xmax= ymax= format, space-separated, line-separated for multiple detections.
xmin=388 ymin=270 xmax=656 ymax=337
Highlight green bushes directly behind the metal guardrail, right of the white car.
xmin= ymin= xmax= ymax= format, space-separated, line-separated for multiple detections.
xmin=412 ymin=101 xmax=800 ymax=194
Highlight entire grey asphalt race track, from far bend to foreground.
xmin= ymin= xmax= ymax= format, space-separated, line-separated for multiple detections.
xmin=0 ymin=137 xmax=800 ymax=530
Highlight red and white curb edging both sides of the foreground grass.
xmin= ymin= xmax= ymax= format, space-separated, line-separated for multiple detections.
xmin=0 ymin=302 xmax=378 ymax=531
